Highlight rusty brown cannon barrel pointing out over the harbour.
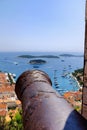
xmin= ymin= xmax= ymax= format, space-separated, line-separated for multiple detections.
xmin=15 ymin=70 xmax=87 ymax=130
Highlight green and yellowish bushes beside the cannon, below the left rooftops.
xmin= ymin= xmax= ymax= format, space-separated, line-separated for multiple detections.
xmin=0 ymin=109 xmax=23 ymax=130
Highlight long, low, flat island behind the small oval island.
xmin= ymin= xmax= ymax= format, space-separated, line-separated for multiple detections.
xmin=18 ymin=55 xmax=59 ymax=58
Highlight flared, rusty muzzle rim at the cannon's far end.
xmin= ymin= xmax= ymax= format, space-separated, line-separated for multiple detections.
xmin=15 ymin=70 xmax=52 ymax=99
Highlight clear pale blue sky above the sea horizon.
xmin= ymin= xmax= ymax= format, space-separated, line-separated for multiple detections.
xmin=0 ymin=0 xmax=85 ymax=52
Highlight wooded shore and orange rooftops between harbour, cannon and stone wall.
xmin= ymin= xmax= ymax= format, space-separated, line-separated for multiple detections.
xmin=64 ymin=68 xmax=83 ymax=113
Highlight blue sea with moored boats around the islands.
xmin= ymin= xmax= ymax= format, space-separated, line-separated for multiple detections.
xmin=0 ymin=52 xmax=84 ymax=95
